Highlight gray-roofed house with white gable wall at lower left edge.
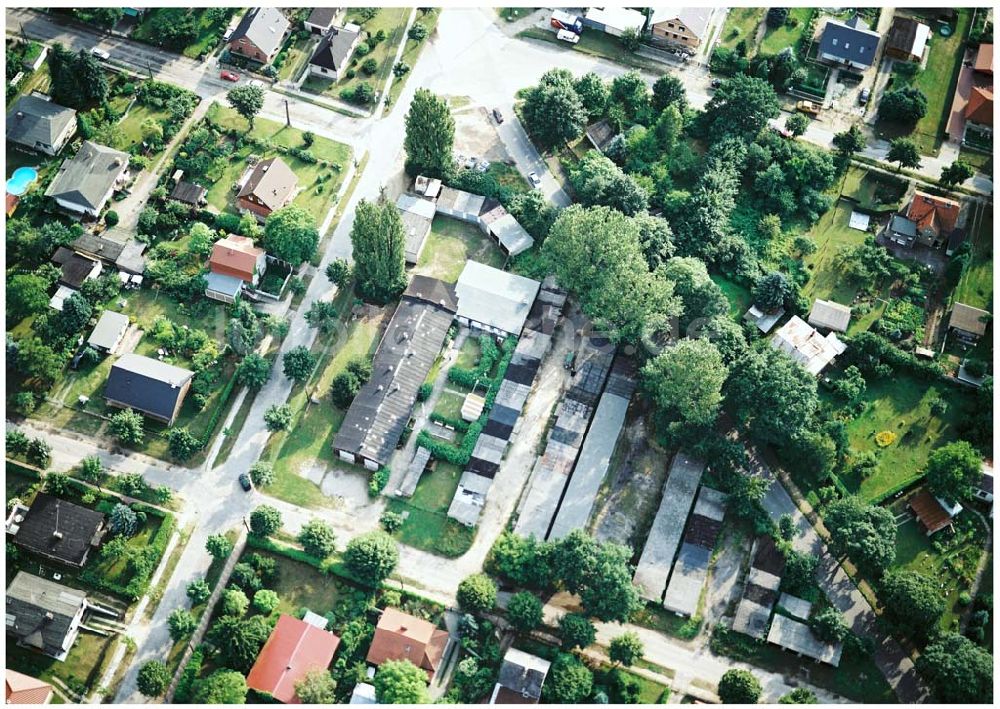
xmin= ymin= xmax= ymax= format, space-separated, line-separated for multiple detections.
xmin=6 ymin=571 xmax=87 ymax=662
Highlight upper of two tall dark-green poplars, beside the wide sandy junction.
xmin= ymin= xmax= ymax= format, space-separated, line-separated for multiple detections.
xmin=403 ymin=89 xmax=455 ymax=177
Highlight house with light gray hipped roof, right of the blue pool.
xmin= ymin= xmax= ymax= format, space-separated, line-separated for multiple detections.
xmin=45 ymin=140 xmax=128 ymax=217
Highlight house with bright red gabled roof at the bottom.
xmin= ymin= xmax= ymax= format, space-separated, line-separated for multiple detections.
xmin=247 ymin=615 xmax=340 ymax=704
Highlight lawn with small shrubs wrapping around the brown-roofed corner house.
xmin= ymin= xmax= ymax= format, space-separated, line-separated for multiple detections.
xmin=202 ymin=104 xmax=351 ymax=224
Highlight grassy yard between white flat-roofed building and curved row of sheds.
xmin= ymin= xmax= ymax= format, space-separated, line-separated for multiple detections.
xmin=414 ymin=216 xmax=504 ymax=283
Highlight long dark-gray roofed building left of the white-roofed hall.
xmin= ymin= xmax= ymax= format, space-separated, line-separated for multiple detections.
xmin=333 ymin=276 xmax=456 ymax=470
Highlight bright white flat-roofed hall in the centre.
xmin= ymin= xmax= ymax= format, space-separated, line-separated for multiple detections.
xmin=455 ymin=261 xmax=541 ymax=335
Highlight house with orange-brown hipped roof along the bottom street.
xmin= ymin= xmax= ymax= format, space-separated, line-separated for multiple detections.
xmin=366 ymin=608 xmax=448 ymax=680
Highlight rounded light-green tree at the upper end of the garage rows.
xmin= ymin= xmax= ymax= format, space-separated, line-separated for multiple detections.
xmin=642 ymin=339 xmax=727 ymax=426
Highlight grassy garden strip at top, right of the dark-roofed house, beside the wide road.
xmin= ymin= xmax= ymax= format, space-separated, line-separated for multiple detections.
xmin=302 ymin=7 xmax=411 ymax=108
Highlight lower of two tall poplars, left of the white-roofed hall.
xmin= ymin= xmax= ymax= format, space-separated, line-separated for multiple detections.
xmin=351 ymin=200 xmax=406 ymax=304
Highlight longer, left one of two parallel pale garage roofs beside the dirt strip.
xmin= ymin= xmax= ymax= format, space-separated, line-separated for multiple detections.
xmin=633 ymin=452 xmax=705 ymax=603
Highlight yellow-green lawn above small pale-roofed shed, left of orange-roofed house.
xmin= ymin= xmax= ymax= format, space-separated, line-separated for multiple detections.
xmin=802 ymin=200 xmax=865 ymax=304
